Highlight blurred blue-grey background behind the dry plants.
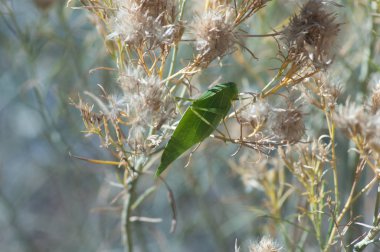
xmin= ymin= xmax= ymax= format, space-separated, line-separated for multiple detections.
xmin=0 ymin=0 xmax=379 ymax=252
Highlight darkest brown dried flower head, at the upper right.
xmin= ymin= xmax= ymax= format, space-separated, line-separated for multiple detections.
xmin=282 ymin=0 xmax=340 ymax=68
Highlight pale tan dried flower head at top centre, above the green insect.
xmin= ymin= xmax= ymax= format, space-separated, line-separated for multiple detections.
xmin=193 ymin=6 xmax=238 ymax=67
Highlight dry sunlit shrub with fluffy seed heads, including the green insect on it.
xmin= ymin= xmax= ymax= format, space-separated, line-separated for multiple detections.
xmin=70 ymin=0 xmax=380 ymax=251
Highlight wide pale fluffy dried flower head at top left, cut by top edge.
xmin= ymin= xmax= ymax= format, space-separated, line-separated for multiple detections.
xmin=108 ymin=0 xmax=183 ymax=49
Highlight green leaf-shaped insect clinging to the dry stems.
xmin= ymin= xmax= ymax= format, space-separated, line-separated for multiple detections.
xmin=156 ymin=82 xmax=238 ymax=176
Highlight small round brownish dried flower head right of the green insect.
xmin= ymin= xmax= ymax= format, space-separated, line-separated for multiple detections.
xmin=272 ymin=107 xmax=305 ymax=143
